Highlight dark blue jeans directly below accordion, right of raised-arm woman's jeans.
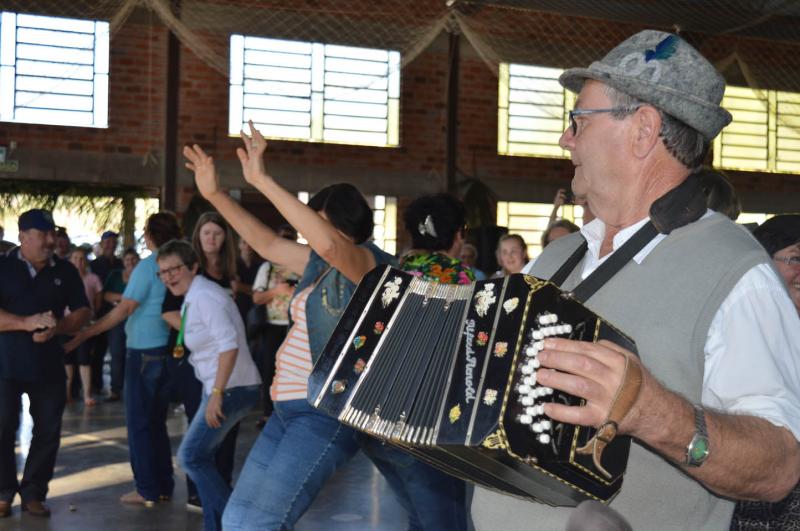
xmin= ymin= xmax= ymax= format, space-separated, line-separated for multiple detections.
xmin=358 ymin=434 xmax=467 ymax=531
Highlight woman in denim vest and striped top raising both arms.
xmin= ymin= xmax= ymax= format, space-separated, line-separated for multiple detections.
xmin=183 ymin=124 xmax=393 ymax=530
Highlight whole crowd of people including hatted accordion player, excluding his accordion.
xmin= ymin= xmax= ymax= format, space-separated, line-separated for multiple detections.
xmin=0 ymin=30 xmax=800 ymax=531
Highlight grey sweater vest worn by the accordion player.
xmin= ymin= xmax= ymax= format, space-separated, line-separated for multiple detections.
xmin=472 ymin=214 xmax=769 ymax=531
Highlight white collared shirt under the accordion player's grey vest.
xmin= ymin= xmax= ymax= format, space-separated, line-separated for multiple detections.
xmin=522 ymin=210 xmax=800 ymax=440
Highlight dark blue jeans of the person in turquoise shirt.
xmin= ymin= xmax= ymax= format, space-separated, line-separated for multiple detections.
xmin=124 ymin=346 xmax=175 ymax=501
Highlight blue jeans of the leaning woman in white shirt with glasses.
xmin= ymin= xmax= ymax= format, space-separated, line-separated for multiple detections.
xmin=178 ymin=385 xmax=260 ymax=531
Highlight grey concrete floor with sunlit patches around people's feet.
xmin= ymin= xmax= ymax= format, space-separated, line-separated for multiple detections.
xmin=0 ymin=402 xmax=406 ymax=531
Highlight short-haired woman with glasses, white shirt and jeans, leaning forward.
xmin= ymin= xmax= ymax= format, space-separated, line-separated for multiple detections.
xmin=157 ymin=240 xmax=261 ymax=531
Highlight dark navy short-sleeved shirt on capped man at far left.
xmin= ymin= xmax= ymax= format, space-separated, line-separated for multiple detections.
xmin=0 ymin=248 xmax=89 ymax=382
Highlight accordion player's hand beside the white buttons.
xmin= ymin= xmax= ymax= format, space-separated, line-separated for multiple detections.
xmin=538 ymin=338 xmax=645 ymax=433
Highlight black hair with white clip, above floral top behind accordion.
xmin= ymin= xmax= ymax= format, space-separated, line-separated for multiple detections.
xmin=403 ymin=194 xmax=466 ymax=251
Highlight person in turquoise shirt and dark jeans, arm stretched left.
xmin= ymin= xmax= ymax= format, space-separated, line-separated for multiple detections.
xmin=64 ymin=212 xmax=181 ymax=507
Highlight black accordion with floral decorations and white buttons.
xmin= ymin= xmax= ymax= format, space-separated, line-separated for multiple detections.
xmin=308 ymin=266 xmax=635 ymax=506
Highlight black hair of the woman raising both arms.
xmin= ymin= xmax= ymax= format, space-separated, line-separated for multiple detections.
xmin=308 ymin=183 xmax=375 ymax=244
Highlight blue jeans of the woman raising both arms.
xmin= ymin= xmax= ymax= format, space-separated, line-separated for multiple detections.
xmin=222 ymin=400 xmax=358 ymax=531
